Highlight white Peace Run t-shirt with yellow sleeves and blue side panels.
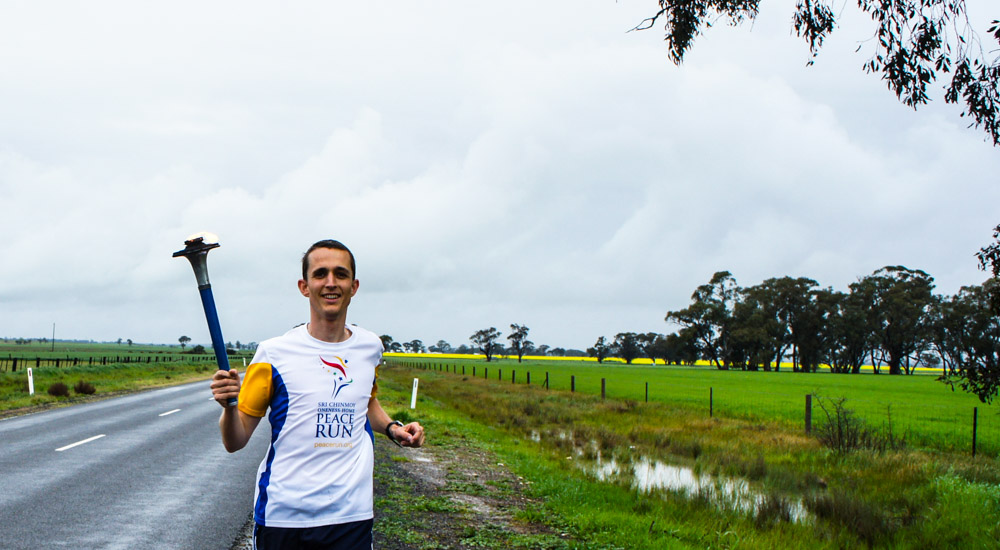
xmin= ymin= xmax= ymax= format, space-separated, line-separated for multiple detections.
xmin=238 ymin=325 xmax=382 ymax=527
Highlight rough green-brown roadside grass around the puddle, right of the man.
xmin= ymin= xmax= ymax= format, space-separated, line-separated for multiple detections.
xmin=380 ymin=364 xmax=1000 ymax=548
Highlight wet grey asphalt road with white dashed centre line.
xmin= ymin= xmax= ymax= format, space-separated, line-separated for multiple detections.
xmin=0 ymin=382 xmax=270 ymax=550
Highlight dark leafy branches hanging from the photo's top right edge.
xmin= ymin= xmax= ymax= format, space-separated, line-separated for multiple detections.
xmin=633 ymin=0 xmax=1000 ymax=146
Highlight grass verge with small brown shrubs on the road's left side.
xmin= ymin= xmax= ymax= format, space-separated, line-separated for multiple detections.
xmin=0 ymin=363 xmax=216 ymax=412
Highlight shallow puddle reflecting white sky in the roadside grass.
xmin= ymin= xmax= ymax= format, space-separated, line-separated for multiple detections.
xmin=584 ymin=454 xmax=812 ymax=523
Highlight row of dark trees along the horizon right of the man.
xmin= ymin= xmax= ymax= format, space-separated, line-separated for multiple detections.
xmin=382 ymin=225 xmax=1000 ymax=403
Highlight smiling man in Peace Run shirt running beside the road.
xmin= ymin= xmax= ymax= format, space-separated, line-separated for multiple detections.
xmin=211 ymin=240 xmax=424 ymax=550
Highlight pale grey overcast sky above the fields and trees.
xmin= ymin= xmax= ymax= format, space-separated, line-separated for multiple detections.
xmin=0 ymin=0 xmax=1000 ymax=349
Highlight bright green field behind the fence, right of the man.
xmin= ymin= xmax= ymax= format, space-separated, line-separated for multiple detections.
xmin=392 ymin=356 xmax=1000 ymax=456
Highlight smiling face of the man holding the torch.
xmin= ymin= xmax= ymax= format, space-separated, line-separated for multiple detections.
xmin=299 ymin=248 xmax=358 ymax=320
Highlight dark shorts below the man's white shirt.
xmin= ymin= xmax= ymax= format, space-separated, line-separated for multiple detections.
xmin=253 ymin=519 xmax=374 ymax=550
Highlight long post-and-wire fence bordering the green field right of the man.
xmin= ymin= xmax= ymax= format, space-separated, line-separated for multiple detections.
xmin=387 ymin=358 xmax=1000 ymax=456
